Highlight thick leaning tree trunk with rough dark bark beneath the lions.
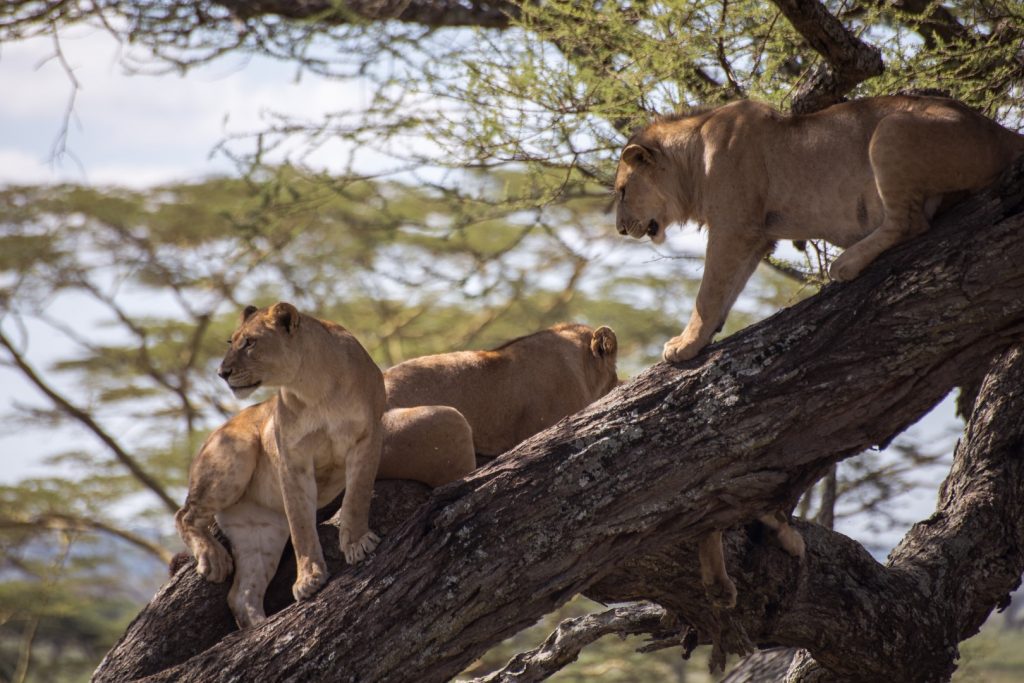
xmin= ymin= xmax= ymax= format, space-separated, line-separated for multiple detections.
xmin=96 ymin=157 xmax=1024 ymax=682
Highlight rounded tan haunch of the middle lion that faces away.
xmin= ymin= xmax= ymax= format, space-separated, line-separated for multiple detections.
xmin=377 ymin=405 xmax=476 ymax=486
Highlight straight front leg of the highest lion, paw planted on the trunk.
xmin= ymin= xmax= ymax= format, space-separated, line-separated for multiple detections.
xmin=662 ymin=228 xmax=770 ymax=362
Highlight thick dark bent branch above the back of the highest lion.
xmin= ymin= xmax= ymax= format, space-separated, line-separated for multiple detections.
xmin=772 ymin=0 xmax=885 ymax=114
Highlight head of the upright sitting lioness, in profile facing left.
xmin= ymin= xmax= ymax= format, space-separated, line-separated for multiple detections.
xmin=217 ymin=302 xmax=302 ymax=398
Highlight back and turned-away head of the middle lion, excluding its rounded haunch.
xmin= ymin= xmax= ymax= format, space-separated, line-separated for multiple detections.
xmin=384 ymin=325 xmax=618 ymax=456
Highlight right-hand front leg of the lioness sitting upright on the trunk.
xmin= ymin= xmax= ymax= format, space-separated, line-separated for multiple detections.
xmin=327 ymin=425 xmax=383 ymax=564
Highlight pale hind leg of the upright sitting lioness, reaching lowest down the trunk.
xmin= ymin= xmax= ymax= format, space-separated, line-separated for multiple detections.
xmin=217 ymin=502 xmax=289 ymax=629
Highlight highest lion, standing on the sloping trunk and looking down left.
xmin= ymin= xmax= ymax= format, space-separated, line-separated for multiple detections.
xmin=615 ymin=96 xmax=1024 ymax=362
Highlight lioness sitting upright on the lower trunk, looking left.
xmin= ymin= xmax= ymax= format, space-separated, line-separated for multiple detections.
xmin=174 ymin=303 xmax=384 ymax=627
